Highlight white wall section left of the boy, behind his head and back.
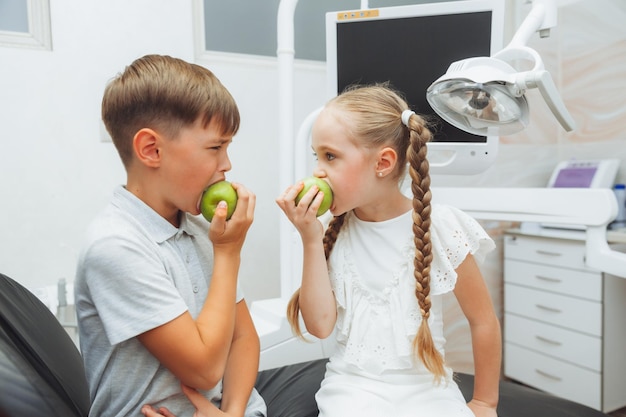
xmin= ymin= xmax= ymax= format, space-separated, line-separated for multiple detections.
xmin=0 ymin=0 xmax=188 ymax=287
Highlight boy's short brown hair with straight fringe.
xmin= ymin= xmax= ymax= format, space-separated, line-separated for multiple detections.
xmin=102 ymin=55 xmax=240 ymax=167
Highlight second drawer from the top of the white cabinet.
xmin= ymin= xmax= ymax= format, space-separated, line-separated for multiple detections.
xmin=504 ymin=259 xmax=602 ymax=301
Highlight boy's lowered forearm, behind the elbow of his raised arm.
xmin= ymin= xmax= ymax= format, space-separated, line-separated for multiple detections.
xmin=221 ymin=300 xmax=260 ymax=416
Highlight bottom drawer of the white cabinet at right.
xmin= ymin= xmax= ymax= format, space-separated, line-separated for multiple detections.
xmin=504 ymin=343 xmax=601 ymax=410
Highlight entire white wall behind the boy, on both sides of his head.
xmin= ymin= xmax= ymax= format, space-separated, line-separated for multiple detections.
xmin=0 ymin=0 xmax=323 ymax=300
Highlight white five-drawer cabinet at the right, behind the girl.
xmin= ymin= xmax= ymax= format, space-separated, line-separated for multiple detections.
xmin=504 ymin=231 xmax=626 ymax=412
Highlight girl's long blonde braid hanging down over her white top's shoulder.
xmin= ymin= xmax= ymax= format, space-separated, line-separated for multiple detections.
xmin=407 ymin=115 xmax=445 ymax=380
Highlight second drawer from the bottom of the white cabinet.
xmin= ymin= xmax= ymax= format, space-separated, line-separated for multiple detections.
xmin=504 ymin=314 xmax=602 ymax=372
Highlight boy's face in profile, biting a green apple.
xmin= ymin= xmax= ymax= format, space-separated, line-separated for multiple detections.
xmin=161 ymin=121 xmax=232 ymax=219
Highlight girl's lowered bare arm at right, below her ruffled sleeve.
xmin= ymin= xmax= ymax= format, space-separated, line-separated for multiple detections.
xmin=454 ymin=255 xmax=502 ymax=417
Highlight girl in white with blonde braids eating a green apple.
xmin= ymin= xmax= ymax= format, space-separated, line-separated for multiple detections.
xmin=277 ymin=85 xmax=501 ymax=417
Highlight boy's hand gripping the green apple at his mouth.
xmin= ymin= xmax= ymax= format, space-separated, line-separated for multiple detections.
xmin=209 ymin=183 xmax=256 ymax=251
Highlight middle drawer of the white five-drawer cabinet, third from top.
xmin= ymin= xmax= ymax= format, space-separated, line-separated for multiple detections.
xmin=504 ymin=283 xmax=602 ymax=337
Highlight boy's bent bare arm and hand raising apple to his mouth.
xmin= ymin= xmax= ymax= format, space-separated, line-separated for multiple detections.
xmin=138 ymin=187 xmax=256 ymax=390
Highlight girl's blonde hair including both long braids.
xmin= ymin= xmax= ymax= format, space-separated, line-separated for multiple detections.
xmin=287 ymin=84 xmax=445 ymax=380
